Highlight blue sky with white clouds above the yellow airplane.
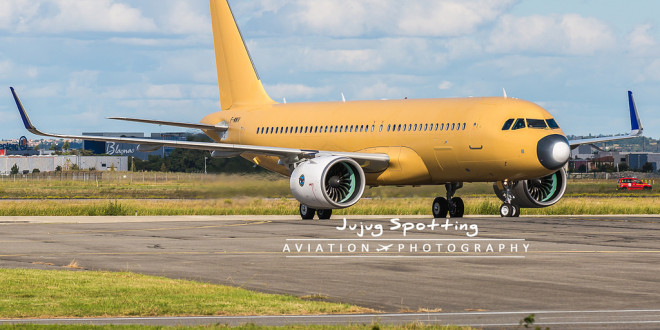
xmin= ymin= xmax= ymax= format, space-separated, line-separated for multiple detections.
xmin=0 ymin=0 xmax=660 ymax=139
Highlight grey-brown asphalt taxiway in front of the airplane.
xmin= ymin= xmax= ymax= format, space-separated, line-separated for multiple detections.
xmin=0 ymin=216 xmax=660 ymax=328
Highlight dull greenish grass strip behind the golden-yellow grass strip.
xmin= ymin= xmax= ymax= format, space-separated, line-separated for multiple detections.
xmin=0 ymin=172 xmax=660 ymax=199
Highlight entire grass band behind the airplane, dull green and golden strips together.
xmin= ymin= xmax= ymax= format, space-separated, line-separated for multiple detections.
xmin=0 ymin=172 xmax=660 ymax=216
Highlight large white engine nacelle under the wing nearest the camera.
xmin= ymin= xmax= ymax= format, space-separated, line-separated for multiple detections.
xmin=289 ymin=156 xmax=365 ymax=209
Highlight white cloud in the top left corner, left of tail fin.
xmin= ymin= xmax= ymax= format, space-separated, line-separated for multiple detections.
xmin=0 ymin=0 xmax=156 ymax=34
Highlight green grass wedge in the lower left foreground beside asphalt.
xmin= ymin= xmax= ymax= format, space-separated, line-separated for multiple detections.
xmin=0 ymin=269 xmax=373 ymax=318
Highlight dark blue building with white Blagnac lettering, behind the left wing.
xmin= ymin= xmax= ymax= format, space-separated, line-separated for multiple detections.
xmin=83 ymin=132 xmax=188 ymax=160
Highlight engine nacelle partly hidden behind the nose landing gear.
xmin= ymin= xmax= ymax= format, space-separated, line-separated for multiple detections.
xmin=493 ymin=168 xmax=568 ymax=208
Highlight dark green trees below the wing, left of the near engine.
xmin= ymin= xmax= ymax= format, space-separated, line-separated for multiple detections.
xmin=129 ymin=134 xmax=266 ymax=173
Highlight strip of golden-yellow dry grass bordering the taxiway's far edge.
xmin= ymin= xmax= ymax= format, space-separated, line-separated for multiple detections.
xmin=0 ymin=197 xmax=660 ymax=217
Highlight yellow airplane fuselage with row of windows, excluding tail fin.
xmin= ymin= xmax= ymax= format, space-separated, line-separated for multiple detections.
xmin=202 ymin=97 xmax=565 ymax=185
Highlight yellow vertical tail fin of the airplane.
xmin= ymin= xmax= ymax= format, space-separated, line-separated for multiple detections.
xmin=209 ymin=0 xmax=275 ymax=110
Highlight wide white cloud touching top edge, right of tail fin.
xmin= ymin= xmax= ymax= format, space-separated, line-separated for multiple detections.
xmin=286 ymin=0 xmax=514 ymax=37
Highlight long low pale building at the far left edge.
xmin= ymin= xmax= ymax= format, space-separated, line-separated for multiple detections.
xmin=0 ymin=155 xmax=128 ymax=175
